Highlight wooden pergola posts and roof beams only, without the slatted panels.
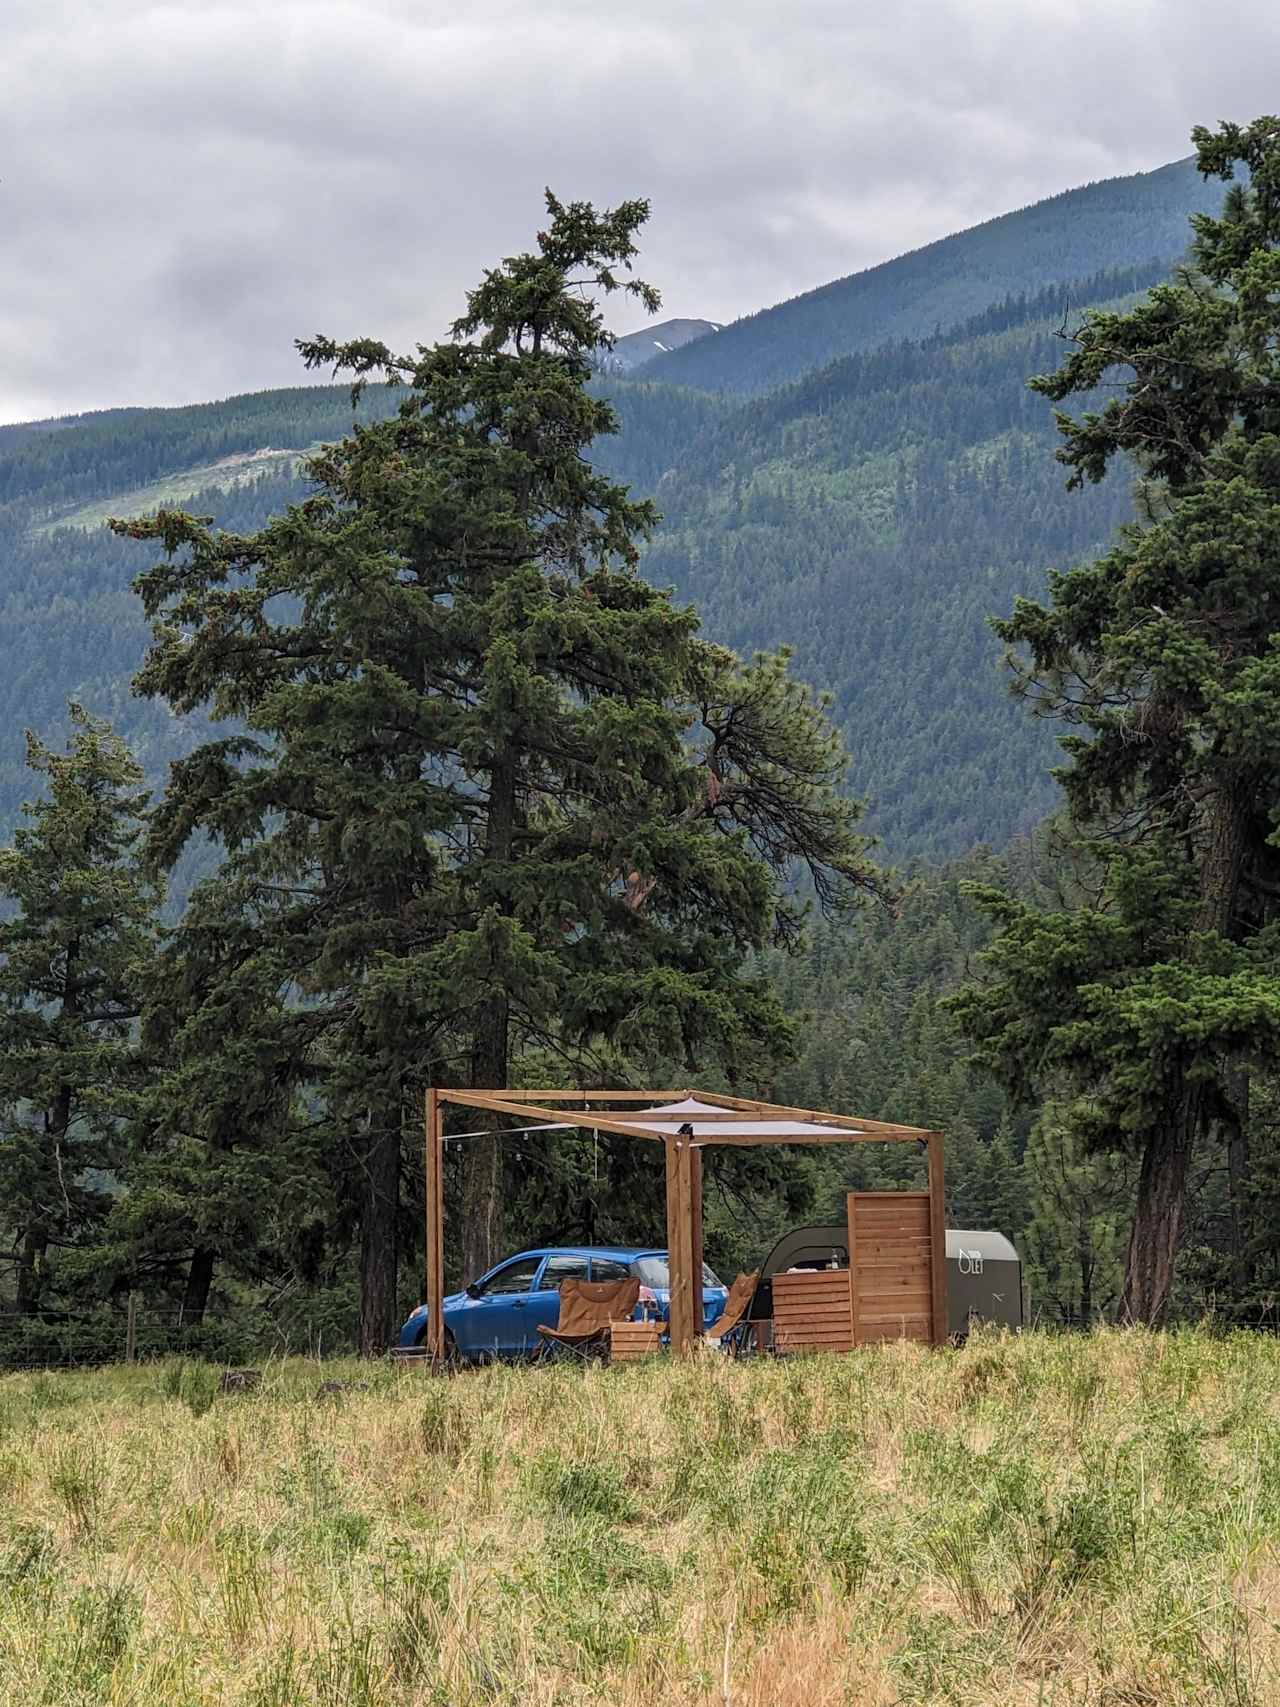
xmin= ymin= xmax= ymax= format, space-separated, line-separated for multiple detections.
xmin=425 ymin=1089 xmax=947 ymax=1360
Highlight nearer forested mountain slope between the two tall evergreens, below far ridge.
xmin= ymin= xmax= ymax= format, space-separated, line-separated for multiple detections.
xmin=645 ymin=266 xmax=1162 ymax=857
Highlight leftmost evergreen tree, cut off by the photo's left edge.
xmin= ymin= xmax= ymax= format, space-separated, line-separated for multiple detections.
xmin=0 ymin=705 xmax=155 ymax=1314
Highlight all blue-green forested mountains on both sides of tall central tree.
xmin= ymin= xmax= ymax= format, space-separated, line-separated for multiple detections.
xmin=0 ymin=164 xmax=1200 ymax=857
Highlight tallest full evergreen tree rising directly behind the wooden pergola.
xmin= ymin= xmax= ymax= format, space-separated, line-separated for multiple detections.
xmin=125 ymin=195 xmax=877 ymax=1350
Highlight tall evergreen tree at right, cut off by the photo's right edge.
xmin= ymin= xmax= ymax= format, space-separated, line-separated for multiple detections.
xmin=961 ymin=118 xmax=1280 ymax=1321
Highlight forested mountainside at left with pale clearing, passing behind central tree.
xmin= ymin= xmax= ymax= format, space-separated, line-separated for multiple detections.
xmin=0 ymin=379 xmax=724 ymax=830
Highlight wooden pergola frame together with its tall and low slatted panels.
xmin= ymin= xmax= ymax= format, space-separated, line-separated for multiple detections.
xmin=423 ymin=1089 xmax=969 ymax=1364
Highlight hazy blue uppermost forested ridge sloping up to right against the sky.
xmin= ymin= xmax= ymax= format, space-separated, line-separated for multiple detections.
xmin=643 ymin=159 xmax=1222 ymax=393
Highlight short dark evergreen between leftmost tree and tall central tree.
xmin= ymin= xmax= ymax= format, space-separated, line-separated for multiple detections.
xmin=101 ymin=872 xmax=336 ymax=1326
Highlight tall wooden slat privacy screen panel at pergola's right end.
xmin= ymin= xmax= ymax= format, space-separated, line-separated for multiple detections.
xmin=848 ymin=1191 xmax=945 ymax=1345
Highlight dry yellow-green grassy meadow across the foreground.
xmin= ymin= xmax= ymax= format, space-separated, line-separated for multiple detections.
xmin=0 ymin=1331 xmax=1280 ymax=1707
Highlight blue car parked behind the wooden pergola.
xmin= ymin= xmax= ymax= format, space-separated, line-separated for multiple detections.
xmin=399 ymin=1244 xmax=729 ymax=1362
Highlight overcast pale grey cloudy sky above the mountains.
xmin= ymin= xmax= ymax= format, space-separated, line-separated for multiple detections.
xmin=0 ymin=0 xmax=1280 ymax=422
